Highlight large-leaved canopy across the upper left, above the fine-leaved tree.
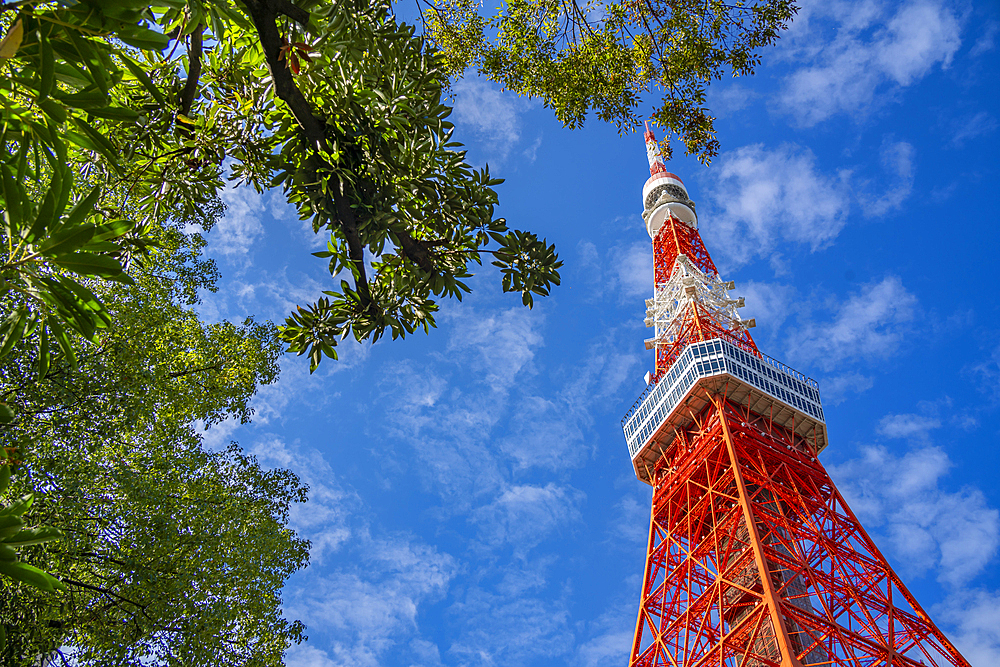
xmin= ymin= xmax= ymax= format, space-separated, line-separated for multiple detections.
xmin=0 ymin=0 xmax=561 ymax=604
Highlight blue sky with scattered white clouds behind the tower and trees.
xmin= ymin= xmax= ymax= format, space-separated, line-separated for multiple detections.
xmin=195 ymin=0 xmax=1000 ymax=667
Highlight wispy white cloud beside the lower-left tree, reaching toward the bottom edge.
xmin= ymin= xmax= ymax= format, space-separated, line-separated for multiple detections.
xmin=252 ymin=436 xmax=458 ymax=667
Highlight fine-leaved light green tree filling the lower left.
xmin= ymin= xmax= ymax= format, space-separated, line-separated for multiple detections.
xmin=0 ymin=229 xmax=308 ymax=665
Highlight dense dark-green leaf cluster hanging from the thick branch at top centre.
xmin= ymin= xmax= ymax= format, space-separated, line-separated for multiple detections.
xmin=243 ymin=0 xmax=561 ymax=369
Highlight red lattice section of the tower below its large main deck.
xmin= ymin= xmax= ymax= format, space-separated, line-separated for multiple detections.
xmin=629 ymin=392 xmax=969 ymax=667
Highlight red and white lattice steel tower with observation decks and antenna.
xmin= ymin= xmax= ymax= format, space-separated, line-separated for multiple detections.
xmin=622 ymin=126 xmax=969 ymax=667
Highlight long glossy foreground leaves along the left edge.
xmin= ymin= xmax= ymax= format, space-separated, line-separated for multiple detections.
xmin=0 ymin=4 xmax=163 ymax=591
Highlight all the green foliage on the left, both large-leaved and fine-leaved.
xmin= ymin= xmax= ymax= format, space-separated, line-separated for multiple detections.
xmin=0 ymin=0 xmax=561 ymax=665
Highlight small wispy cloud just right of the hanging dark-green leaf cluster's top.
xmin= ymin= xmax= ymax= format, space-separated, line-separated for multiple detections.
xmin=452 ymin=79 xmax=525 ymax=162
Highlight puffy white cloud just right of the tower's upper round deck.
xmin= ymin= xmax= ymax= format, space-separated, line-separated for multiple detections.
xmin=704 ymin=144 xmax=850 ymax=264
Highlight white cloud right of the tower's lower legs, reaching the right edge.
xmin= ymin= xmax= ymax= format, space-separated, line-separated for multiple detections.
xmin=830 ymin=447 xmax=1000 ymax=586
